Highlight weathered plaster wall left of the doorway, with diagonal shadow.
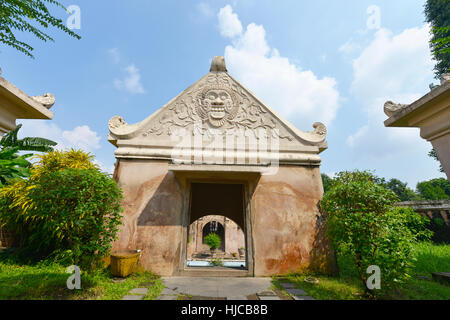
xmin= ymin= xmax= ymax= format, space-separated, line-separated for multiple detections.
xmin=113 ymin=160 xmax=183 ymax=275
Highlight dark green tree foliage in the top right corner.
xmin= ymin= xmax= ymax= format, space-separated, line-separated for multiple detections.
xmin=425 ymin=0 xmax=450 ymax=79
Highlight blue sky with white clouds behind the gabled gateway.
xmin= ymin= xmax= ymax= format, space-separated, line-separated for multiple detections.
xmin=0 ymin=0 xmax=444 ymax=188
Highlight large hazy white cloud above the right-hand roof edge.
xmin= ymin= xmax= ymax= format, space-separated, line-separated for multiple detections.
xmin=347 ymin=25 xmax=433 ymax=158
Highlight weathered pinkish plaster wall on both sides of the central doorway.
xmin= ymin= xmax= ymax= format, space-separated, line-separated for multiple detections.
xmin=113 ymin=159 xmax=334 ymax=276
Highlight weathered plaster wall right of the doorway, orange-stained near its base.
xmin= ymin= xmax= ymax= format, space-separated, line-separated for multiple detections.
xmin=251 ymin=167 xmax=333 ymax=276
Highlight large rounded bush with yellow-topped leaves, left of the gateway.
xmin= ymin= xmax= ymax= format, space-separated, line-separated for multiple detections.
xmin=0 ymin=150 xmax=122 ymax=267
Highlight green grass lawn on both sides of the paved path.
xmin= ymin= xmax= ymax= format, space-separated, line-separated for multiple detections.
xmin=0 ymin=243 xmax=450 ymax=300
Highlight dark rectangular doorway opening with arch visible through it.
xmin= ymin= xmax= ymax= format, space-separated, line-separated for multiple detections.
xmin=185 ymin=181 xmax=252 ymax=272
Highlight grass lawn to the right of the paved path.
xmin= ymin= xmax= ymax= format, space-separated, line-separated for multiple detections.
xmin=273 ymin=243 xmax=450 ymax=300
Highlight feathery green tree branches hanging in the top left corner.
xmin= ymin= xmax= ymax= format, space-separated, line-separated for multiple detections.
xmin=0 ymin=0 xmax=81 ymax=58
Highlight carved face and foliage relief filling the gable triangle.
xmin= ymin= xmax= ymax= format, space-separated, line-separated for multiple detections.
xmin=143 ymin=73 xmax=293 ymax=141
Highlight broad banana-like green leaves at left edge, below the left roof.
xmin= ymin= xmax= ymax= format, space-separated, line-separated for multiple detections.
xmin=0 ymin=124 xmax=56 ymax=187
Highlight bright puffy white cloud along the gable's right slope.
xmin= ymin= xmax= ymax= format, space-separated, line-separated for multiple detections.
xmin=219 ymin=6 xmax=340 ymax=130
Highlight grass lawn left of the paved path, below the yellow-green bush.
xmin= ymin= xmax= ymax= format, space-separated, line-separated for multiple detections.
xmin=0 ymin=253 xmax=164 ymax=300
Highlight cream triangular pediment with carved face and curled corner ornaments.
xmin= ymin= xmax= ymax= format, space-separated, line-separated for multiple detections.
xmin=109 ymin=57 xmax=327 ymax=165
